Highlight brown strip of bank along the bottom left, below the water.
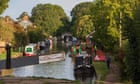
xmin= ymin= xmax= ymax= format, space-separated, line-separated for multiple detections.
xmin=0 ymin=77 xmax=79 ymax=84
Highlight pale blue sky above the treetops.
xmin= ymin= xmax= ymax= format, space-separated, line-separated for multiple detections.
xmin=1 ymin=0 xmax=93 ymax=20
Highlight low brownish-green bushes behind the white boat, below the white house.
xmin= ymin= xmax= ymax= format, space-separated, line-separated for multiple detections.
xmin=14 ymin=27 xmax=46 ymax=47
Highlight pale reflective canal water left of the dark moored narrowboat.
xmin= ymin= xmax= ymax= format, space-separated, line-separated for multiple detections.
xmin=13 ymin=40 xmax=94 ymax=84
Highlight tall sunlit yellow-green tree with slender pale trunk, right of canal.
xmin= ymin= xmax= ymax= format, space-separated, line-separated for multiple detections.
xmin=92 ymin=0 xmax=132 ymax=50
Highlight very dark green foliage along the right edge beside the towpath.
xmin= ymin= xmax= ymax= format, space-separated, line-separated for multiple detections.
xmin=126 ymin=5 xmax=140 ymax=84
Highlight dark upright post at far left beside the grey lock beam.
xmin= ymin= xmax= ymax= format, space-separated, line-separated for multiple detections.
xmin=5 ymin=44 xmax=11 ymax=69
